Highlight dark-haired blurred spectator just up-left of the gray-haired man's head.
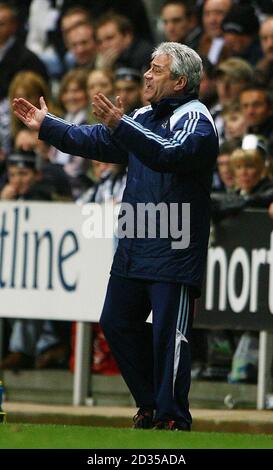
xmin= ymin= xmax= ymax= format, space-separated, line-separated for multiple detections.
xmin=96 ymin=14 xmax=152 ymax=72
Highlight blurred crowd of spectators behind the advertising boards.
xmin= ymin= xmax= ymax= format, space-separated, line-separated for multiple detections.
xmin=0 ymin=0 xmax=273 ymax=382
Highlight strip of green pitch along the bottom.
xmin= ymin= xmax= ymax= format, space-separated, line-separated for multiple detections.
xmin=0 ymin=424 xmax=273 ymax=449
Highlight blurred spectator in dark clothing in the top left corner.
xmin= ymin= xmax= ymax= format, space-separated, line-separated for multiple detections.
xmin=0 ymin=2 xmax=48 ymax=101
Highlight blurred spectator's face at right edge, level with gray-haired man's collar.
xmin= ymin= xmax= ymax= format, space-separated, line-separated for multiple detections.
xmin=240 ymin=90 xmax=272 ymax=127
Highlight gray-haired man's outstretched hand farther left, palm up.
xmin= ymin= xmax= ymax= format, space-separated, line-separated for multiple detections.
xmin=12 ymin=96 xmax=48 ymax=131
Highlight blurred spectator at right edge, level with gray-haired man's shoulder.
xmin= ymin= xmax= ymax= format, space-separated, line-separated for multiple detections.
xmin=240 ymin=84 xmax=273 ymax=160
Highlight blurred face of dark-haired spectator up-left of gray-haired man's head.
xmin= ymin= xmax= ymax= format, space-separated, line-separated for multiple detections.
xmin=96 ymin=21 xmax=132 ymax=55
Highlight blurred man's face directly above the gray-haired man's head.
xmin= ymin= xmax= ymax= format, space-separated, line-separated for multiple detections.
xmin=161 ymin=4 xmax=189 ymax=42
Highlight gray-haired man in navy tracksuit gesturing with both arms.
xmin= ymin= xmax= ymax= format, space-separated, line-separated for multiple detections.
xmin=13 ymin=43 xmax=218 ymax=430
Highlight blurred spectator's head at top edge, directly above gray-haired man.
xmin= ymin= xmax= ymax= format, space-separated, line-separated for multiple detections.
xmin=161 ymin=0 xmax=201 ymax=49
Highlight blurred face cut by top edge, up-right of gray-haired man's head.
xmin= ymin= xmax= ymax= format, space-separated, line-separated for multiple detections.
xmin=203 ymin=0 xmax=232 ymax=38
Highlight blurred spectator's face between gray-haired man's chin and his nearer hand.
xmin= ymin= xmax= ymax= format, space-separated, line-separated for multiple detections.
xmin=115 ymin=80 xmax=142 ymax=113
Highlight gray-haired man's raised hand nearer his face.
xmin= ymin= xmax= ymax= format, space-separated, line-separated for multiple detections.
xmin=92 ymin=93 xmax=124 ymax=129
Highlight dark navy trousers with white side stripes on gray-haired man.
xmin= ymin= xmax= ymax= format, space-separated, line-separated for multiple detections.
xmin=100 ymin=275 xmax=194 ymax=423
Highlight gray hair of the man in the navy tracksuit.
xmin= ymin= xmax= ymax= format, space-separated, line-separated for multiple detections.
xmin=152 ymin=42 xmax=203 ymax=93
